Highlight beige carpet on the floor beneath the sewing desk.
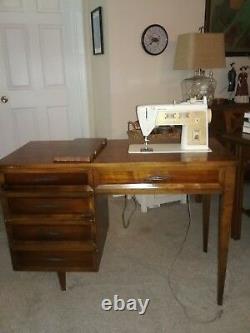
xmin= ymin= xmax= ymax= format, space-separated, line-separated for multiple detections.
xmin=0 ymin=189 xmax=250 ymax=333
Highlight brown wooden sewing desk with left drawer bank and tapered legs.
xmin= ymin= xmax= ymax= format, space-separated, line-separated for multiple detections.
xmin=0 ymin=140 xmax=236 ymax=305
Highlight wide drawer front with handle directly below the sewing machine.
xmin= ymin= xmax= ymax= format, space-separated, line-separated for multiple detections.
xmin=94 ymin=167 xmax=219 ymax=185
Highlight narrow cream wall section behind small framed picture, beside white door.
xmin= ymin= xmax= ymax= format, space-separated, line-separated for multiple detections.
xmin=83 ymin=0 xmax=112 ymax=138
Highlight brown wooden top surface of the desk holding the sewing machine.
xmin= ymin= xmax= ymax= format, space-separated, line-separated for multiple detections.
xmin=0 ymin=139 xmax=235 ymax=171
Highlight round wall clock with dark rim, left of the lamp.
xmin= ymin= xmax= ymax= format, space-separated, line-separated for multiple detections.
xmin=141 ymin=24 xmax=168 ymax=55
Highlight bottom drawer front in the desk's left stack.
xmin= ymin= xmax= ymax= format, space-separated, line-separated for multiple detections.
xmin=12 ymin=251 xmax=98 ymax=271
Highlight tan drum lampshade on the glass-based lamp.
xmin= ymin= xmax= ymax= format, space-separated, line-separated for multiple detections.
xmin=174 ymin=33 xmax=225 ymax=69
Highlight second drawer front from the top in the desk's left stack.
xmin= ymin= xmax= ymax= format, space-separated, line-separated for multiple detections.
xmin=8 ymin=195 xmax=93 ymax=214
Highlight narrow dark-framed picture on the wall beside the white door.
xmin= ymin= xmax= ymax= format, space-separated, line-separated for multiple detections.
xmin=91 ymin=7 xmax=104 ymax=55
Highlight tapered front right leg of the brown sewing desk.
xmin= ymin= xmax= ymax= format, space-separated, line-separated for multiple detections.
xmin=217 ymin=167 xmax=235 ymax=305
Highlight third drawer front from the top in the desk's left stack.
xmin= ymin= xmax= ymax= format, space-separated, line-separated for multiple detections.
xmin=8 ymin=223 xmax=94 ymax=241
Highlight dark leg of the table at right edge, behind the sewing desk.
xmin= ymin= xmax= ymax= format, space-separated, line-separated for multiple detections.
xmin=231 ymin=144 xmax=244 ymax=240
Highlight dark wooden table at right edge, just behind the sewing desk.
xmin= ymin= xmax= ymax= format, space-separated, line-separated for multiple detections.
xmin=223 ymin=133 xmax=250 ymax=239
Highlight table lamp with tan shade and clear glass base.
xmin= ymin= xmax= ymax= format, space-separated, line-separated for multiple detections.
xmin=174 ymin=32 xmax=225 ymax=105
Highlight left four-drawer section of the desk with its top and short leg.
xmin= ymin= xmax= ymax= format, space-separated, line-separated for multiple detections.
xmin=0 ymin=139 xmax=108 ymax=290
